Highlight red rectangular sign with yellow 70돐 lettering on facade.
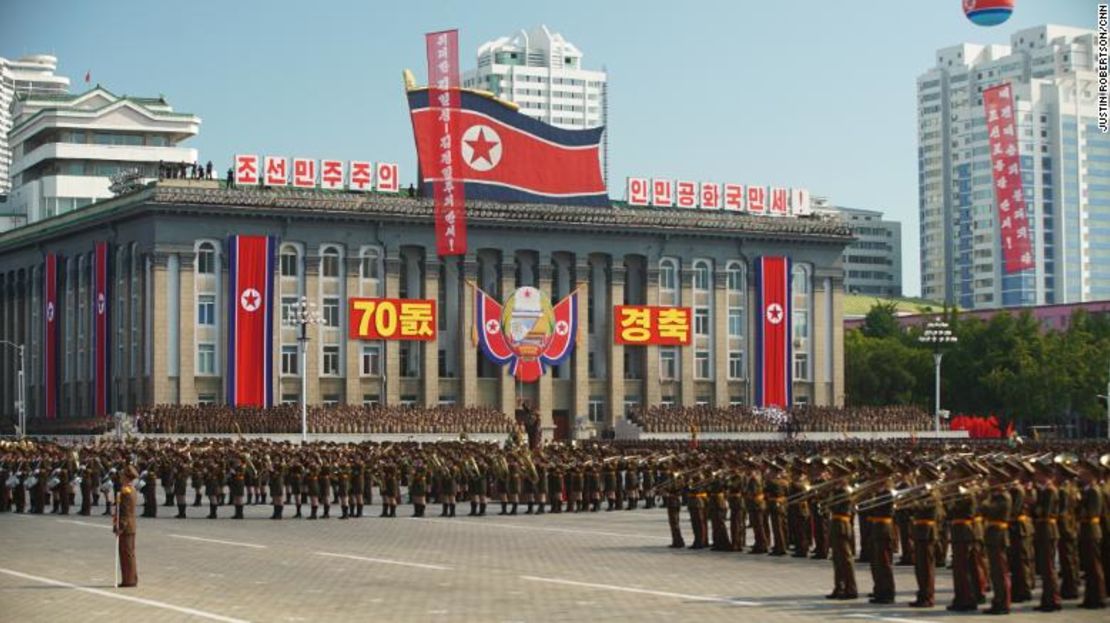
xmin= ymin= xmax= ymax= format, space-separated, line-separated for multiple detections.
xmin=347 ymin=299 xmax=436 ymax=342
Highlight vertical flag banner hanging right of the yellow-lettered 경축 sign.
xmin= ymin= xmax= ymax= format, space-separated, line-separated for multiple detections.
xmin=755 ymin=255 xmax=793 ymax=409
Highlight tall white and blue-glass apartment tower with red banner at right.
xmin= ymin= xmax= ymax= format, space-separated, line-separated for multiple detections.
xmin=917 ymin=26 xmax=1110 ymax=309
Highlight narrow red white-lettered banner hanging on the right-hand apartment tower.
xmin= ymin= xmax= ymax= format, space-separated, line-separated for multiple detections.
xmin=982 ymin=83 xmax=1033 ymax=273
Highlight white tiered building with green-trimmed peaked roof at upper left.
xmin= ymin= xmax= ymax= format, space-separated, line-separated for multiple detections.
xmin=8 ymin=86 xmax=201 ymax=229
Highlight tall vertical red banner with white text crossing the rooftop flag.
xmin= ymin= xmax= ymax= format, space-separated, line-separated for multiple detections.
xmin=421 ymin=30 xmax=466 ymax=255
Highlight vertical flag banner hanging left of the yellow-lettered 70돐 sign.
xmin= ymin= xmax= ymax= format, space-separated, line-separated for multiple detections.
xmin=228 ymin=235 xmax=275 ymax=406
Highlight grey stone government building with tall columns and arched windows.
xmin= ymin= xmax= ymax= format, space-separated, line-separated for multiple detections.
xmin=0 ymin=180 xmax=852 ymax=436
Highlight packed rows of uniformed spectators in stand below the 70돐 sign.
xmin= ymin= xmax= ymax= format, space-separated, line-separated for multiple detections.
xmin=135 ymin=404 xmax=515 ymax=434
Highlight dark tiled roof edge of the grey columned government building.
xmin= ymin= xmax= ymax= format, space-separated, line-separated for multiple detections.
xmin=0 ymin=182 xmax=855 ymax=251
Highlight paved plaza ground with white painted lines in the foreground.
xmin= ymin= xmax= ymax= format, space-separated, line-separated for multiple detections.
xmin=0 ymin=504 xmax=1107 ymax=623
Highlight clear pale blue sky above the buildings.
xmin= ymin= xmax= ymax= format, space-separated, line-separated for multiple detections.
xmin=0 ymin=0 xmax=1097 ymax=293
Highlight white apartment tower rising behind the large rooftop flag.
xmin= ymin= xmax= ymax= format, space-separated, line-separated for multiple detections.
xmin=463 ymin=26 xmax=608 ymax=180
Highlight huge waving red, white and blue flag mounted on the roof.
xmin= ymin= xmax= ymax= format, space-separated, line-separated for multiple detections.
xmin=408 ymin=89 xmax=609 ymax=205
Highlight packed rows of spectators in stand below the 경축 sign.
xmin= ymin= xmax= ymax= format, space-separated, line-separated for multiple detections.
xmin=629 ymin=404 xmax=934 ymax=434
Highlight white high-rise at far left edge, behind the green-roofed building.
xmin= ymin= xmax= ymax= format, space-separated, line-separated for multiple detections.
xmin=0 ymin=54 xmax=69 ymax=203
